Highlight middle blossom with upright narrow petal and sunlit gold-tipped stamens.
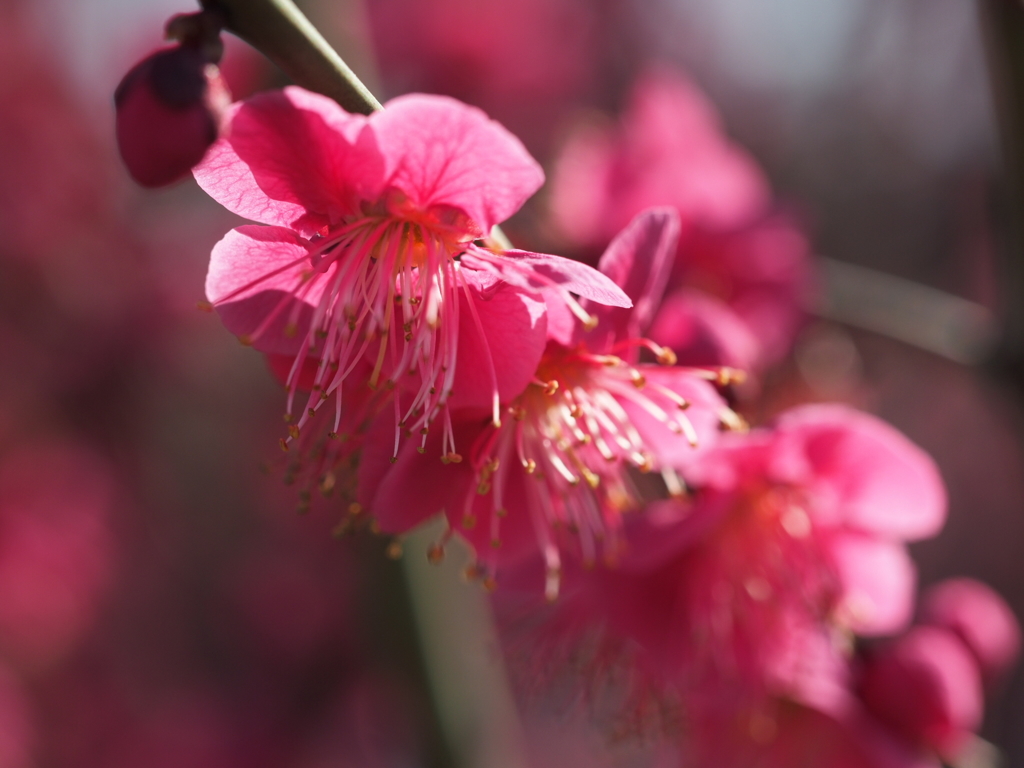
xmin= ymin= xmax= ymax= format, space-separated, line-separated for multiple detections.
xmin=359 ymin=209 xmax=735 ymax=598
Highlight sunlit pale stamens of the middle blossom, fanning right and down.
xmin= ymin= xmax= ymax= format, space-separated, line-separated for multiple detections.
xmin=462 ymin=345 xmax=696 ymax=599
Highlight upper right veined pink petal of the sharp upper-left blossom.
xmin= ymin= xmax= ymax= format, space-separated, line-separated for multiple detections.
xmin=370 ymin=94 xmax=544 ymax=234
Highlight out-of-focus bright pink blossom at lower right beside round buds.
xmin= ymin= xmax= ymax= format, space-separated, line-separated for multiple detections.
xmin=516 ymin=406 xmax=945 ymax=729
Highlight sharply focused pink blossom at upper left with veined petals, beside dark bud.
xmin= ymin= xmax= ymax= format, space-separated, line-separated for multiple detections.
xmin=195 ymin=87 xmax=629 ymax=454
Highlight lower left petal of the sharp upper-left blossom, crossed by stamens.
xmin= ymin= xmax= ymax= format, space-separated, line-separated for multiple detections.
xmin=206 ymin=225 xmax=323 ymax=356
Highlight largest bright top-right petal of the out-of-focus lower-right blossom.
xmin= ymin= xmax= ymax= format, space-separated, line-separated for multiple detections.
xmin=775 ymin=406 xmax=946 ymax=540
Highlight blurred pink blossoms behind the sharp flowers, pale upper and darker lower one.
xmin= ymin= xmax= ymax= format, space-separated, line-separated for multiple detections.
xmin=551 ymin=70 xmax=813 ymax=373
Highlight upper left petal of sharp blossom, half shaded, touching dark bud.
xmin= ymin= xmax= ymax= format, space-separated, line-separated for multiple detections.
xmin=194 ymin=86 xmax=383 ymax=236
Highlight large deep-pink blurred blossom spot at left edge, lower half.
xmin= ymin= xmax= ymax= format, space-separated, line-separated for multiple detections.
xmin=0 ymin=442 xmax=114 ymax=669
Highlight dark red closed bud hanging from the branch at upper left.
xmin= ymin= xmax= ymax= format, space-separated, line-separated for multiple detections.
xmin=114 ymin=45 xmax=231 ymax=186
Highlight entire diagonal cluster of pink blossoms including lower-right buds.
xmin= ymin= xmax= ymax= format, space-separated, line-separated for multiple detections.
xmin=195 ymin=72 xmax=1019 ymax=768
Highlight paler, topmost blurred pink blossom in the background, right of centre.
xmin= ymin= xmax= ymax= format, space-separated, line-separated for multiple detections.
xmin=551 ymin=69 xmax=771 ymax=248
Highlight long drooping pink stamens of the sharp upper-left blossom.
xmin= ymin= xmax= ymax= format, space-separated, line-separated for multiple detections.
xmin=268 ymin=215 xmax=468 ymax=449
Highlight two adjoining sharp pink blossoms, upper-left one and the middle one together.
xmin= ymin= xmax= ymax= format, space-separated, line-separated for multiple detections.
xmin=196 ymin=88 xmax=735 ymax=597
